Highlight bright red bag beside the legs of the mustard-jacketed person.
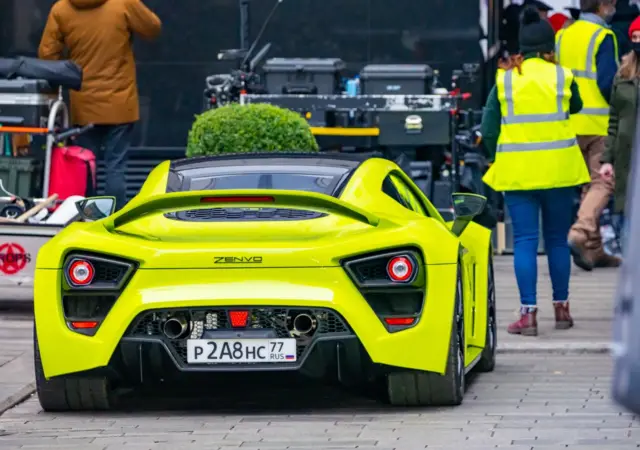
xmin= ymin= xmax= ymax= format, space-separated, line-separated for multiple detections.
xmin=49 ymin=145 xmax=96 ymax=200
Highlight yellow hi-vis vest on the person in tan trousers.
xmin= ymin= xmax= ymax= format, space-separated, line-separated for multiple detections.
xmin=556 ymin=20 xmax=618 ymax=136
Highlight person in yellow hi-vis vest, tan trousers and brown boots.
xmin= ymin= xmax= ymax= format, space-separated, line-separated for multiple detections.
xmin=556 ymin=0 xmax=621 ymax=270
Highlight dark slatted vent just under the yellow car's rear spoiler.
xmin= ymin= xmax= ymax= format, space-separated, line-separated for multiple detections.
xmin=165 ymin=208 xmax=326 ymax=222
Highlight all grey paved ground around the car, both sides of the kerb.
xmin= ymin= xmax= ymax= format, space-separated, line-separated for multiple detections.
xmin=0 ymin=257 xmax=640 ymax=450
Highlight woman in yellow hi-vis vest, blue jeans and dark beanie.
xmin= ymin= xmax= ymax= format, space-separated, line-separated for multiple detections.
xmin=481 ymin=8 xmax=589 ymax=336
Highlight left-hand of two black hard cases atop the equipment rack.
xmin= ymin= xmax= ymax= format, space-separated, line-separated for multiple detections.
xmin=264 ymin=58 xmax=345 ymax=95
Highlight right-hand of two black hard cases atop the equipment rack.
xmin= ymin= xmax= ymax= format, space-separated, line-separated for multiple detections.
xmin=360 ymin=64 xmax=433 ymax=95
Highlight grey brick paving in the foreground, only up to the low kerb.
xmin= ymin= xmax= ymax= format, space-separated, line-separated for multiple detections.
xmin=0 ymin=354 xmax=640 ymax=450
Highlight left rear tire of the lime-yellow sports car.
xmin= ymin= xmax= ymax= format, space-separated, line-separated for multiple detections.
xmin=33 ymin=326 xmax=111 ymax=412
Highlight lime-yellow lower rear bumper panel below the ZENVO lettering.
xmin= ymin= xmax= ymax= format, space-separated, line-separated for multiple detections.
xmin=34 ymin=264 xmax=457 ymax=377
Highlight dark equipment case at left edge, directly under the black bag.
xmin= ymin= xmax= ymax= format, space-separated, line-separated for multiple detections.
xmin=0 ymin=78 xmax=57 ymax=128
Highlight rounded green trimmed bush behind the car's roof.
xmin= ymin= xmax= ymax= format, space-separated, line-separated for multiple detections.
xmin=187 ymin=103 xmax=318 ymax=157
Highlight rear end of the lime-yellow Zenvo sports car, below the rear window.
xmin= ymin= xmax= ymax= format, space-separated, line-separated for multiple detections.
xmin=35 ymin=158 xmax=464 ymax=410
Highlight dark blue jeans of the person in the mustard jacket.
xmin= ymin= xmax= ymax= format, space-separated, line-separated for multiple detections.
xmin=76 ymin=123 xmax=134 ymax=210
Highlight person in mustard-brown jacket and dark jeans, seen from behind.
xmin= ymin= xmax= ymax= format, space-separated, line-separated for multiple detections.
xmin=38 ymin=0 xmax=161 ymax=209
